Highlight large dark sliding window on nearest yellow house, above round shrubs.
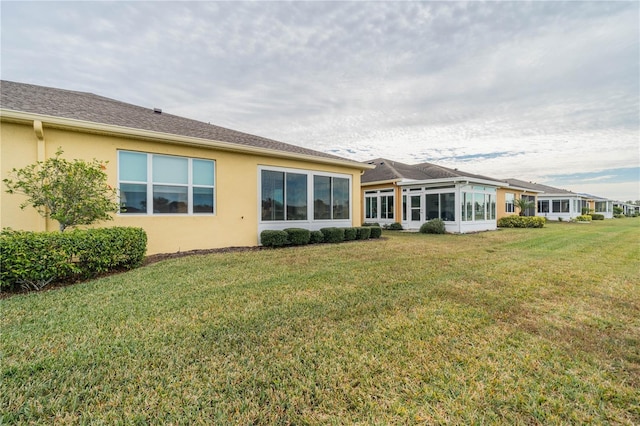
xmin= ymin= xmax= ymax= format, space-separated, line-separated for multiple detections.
xmin=260 ymin=168 xmax=351 ymax=221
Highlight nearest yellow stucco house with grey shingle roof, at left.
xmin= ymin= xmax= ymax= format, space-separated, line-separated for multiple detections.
xmin=0 ymin=81 xmax=373 ymax=254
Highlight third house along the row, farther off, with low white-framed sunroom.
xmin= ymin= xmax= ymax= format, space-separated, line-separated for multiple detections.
xmin=505 ymin=179 xmax=613 ymax=221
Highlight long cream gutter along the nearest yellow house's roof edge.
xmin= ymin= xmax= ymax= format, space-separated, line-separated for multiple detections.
xmin=0 ymin=109 xmax=375 ymax=170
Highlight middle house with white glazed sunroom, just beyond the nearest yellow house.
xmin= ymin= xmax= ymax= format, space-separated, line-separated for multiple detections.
xmin=361 ymin=158 xmax=508 ymax=233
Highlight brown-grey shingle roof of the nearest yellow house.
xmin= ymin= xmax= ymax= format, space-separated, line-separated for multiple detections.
xmin=0 ymin=80 xmax=355 ymax=163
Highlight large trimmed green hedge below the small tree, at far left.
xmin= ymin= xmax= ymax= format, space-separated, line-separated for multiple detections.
xmin=0 ymin=227 xmax=147 ymax=290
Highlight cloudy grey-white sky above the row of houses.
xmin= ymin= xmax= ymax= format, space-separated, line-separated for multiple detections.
xmin=0 ymin=1 xmax=640 ymax=201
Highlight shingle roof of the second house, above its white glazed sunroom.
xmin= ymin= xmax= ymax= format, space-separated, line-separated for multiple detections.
xmin=361 ymin=158 xmax=500 ymax=183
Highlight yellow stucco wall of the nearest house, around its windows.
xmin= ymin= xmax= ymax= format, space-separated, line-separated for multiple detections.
xmin=0 ymin=118 xmax=362 ymax=254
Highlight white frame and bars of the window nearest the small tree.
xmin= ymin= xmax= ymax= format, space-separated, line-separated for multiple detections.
xmin=116 ymin=149 xmax=218 ymax=217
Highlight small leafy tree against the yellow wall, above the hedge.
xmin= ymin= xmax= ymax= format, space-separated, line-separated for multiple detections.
xmin=3 ymin=148 xmax=119 ymax=231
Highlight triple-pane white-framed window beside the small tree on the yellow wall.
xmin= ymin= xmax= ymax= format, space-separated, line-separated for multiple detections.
xmin=118 ymin=151 xmax=215 ymax=214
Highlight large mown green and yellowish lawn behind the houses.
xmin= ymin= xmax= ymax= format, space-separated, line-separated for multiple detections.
xmin=0 ymin=219 xmax=640 ymax=424
